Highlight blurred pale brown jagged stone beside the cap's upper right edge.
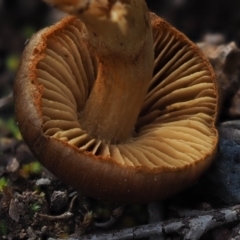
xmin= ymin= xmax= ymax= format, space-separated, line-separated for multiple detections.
xmin=198 ymin=42 xmax=240 ymax=118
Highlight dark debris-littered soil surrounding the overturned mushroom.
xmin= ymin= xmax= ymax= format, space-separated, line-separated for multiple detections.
xmin=0 ymin=0 xmax=240 ymax=239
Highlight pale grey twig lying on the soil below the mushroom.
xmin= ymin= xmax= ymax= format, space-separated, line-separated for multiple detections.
xmin=72 ymin=205 xmax=240 ymax=240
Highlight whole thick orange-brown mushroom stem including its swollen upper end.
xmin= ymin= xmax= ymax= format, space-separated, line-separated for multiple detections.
xmin=48 ymin=0 xmax=153 ymax=143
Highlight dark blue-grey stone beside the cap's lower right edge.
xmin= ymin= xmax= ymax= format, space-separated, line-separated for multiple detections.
xmin=198 ymin=138 xmax=240 ymax=205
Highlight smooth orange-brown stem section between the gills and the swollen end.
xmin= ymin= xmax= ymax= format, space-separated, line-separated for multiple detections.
xmin=80 ymin=49 xmax=151 ymax=143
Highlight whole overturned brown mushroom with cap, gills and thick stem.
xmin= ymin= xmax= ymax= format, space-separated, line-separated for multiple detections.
xmin=14 ymin=0 xmax=219 ymax=202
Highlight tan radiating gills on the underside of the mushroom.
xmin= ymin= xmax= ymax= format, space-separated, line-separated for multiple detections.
xmin=36 ymin=14 xmax=217 ymax=171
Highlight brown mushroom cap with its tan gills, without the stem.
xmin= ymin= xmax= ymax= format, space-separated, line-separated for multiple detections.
xmin=14 ymin=14 xmax=219 ymax=202
